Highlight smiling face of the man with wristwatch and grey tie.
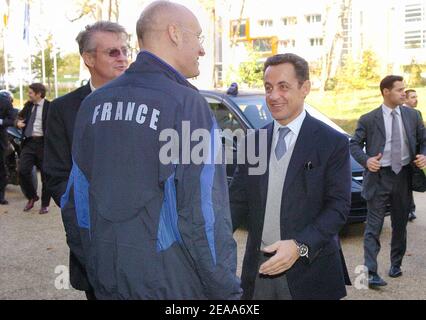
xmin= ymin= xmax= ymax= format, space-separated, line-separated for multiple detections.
xmin=264 ymin=63 xmax=311 ymax=126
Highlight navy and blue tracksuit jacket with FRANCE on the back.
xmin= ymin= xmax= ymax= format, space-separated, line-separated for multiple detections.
xmin=62 ymin=51 xmax=241 ymax=300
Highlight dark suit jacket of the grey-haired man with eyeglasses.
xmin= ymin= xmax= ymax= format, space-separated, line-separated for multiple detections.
xmin=43 ymin=84 xmax=91 ymax=291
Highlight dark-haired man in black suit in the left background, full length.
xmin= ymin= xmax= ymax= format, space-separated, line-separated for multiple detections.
xmin=16 ymin=83 xmax=50 ymax=214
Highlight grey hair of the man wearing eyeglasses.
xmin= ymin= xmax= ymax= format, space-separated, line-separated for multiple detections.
xmin=75 ymin=21 xmax=128 ymax=55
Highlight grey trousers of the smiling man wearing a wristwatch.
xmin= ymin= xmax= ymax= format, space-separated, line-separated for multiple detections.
xmin=253 ymin=252 xmax=293 ymax=300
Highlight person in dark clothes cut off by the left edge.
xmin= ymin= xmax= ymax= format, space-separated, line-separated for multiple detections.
xmin=0 ymin=90 xmax=15 ymax=205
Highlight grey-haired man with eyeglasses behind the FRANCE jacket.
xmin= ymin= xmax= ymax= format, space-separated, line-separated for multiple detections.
xmin=44 ymin=21 xmax=128 ymax=300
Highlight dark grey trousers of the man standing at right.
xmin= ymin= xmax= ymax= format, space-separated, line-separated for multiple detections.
xmin=364 ymin=166 xmax=411 ymax=273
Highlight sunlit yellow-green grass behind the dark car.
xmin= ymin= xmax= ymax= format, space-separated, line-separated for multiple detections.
xmin=306 ymin=87 xmax=426 ymax=134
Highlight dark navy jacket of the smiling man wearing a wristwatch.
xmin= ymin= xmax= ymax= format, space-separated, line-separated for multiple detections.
xmin=230 ymin=114 xmax=351 ymax=300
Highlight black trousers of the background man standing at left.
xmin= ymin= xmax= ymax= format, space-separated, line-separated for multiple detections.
xmin=19 ymin=138 xmax=50 ymax=207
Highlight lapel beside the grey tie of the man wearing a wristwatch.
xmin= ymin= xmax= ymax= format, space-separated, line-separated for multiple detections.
xmin=283 ymin=113 xmax=316 ymax=194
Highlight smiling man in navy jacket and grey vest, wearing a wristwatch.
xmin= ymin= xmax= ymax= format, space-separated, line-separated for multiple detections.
xmin=230 ymin=54 xmax=351 ymax=300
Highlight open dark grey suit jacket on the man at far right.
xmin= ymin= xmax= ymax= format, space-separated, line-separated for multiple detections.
xmin=350 ymin=106 xmax=426 ymax=200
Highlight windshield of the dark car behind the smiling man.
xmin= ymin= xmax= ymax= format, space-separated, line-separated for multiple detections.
xmin=231 ymin=95 xmax=347 ymax=134
